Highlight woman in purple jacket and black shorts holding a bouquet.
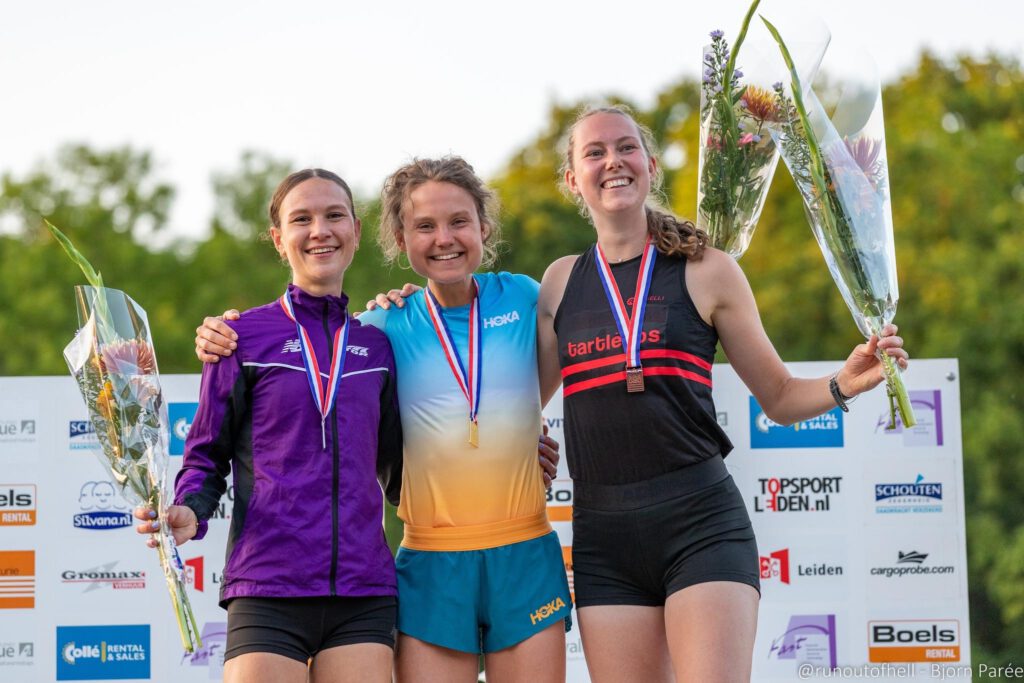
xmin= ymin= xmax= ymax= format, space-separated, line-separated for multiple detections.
xmin=136 ymin=169 xmax=401 ymax=683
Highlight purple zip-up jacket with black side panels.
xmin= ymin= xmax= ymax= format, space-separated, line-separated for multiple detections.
xmin=174 ymin=285 xmax=402 ymax=605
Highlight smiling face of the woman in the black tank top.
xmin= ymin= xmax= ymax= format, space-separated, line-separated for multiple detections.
xmin=565 ymin=112 xmax=656 ymax=216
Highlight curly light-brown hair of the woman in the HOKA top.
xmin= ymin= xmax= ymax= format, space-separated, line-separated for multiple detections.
xmin=377 ymin=155 xmax=502 ymax=267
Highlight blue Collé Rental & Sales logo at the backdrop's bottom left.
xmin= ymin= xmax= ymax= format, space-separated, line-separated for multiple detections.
xmin=56 ymin=624 xmax=151 ymax=681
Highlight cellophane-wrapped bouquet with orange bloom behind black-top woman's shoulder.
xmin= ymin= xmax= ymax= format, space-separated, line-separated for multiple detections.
xmin=696 ymin=0 xmax=829 ymax=259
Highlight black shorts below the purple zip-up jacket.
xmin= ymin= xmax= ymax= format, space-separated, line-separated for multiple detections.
xmin=224 ymin=596 xmax=398 ymax=663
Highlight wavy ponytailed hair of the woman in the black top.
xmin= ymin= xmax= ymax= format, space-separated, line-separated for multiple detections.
xmin=559 ymin=104 xmax=708 ymax=260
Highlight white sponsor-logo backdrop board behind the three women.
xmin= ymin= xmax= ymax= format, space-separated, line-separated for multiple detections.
xmin=0 ymin=359 xmax=970 ymax=683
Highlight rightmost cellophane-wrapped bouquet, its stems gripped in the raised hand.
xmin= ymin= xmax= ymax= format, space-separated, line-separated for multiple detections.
xmin=762 ymin=17 xmax=916 ymax=429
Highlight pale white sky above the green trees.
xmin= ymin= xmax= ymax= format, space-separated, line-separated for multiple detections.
xmin=6 ymin=0 xmax=1024 ymax=245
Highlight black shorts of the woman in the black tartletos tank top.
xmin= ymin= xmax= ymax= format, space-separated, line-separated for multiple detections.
xmin=572 ymin=456 xmax=761 ymax=607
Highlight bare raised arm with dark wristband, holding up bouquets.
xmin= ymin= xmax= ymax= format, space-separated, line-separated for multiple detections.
xmin=686 ymin=249 xmax=908 ymax=424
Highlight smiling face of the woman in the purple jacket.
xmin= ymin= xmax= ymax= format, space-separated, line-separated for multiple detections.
xmin=270 ymin=177 xmax=361 ymax=296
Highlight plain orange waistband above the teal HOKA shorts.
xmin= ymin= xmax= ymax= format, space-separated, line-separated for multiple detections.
xmin=401 ymin=510 xmax=551 ymax=552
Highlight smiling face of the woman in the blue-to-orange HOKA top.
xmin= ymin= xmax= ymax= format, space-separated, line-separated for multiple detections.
xmin=395 ymin=180 xmax=489 ymax=286
